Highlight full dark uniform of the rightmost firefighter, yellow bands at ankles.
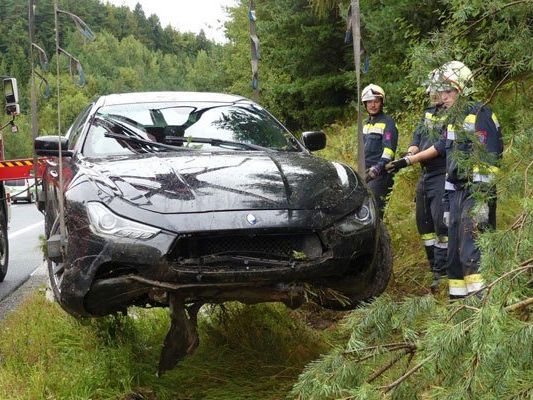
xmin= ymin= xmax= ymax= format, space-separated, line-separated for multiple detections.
xmin=435 ymin=104 xmax=503 ymax=298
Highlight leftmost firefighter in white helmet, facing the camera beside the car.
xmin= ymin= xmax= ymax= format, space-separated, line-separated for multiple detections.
xmin=361 ymin=84 xmax=398 ymax=217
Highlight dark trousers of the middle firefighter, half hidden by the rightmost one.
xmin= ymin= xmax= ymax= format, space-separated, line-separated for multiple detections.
xmin=415 ymin=172 xmax=448 ymax=276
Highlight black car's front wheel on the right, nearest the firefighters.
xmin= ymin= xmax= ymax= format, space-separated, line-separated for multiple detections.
xmin=318 ymin=222 xmax=392 ymax=311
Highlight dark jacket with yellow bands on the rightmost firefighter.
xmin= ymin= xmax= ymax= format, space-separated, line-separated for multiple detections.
xmin=435 ymin=103 xmax=503 ymax=189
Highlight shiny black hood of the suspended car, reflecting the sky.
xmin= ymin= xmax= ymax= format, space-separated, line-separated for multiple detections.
xmin=83 ymin=151 xmax=366 ymax=214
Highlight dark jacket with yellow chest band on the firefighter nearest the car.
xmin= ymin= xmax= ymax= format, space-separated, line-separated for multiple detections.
xmin=363 ymin=112 xmax=398 ymax=173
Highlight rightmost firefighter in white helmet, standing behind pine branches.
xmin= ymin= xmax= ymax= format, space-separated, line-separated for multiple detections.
xmin=387 ymin=61 xmax=503 ymax=299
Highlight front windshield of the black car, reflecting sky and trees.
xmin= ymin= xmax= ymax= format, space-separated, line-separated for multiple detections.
xmin=83 ymin=102 xmax=301 ymax=157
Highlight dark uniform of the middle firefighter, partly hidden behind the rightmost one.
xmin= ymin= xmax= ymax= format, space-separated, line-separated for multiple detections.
xmin=410 ymin=106 xmax=448 ymax=280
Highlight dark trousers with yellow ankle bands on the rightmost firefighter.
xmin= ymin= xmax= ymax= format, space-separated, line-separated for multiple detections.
xmin=448 ymin=189 xmax=496 ymax=298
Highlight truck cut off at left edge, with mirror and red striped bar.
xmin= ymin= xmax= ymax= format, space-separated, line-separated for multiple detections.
xmin=0 ymin=77 xmax=41 ymax=282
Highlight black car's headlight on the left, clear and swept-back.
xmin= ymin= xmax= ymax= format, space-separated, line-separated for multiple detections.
xmin=87 ymin=201 xmax=161 ymax=240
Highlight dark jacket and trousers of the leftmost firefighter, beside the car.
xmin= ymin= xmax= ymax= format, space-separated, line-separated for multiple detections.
xmin=363 ymin=112 xmax=398 ymax=217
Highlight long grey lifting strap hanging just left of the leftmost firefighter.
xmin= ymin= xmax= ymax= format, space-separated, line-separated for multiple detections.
xmin=350 ymin=0 xmax=365 ymax=174
